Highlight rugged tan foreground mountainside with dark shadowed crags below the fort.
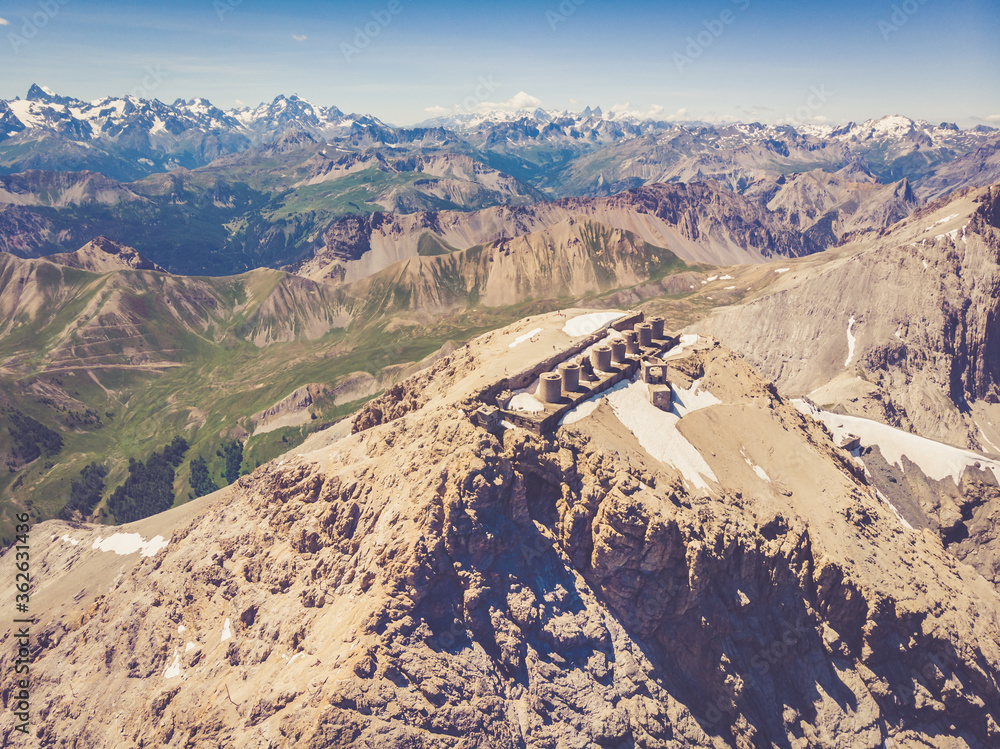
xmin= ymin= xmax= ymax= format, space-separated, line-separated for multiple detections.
xmin=0 ymin=340 xmax=1000 ymax=749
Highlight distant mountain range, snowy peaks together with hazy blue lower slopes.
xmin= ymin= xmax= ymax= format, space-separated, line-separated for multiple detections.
xmin=0 ymin=85 xmax=1000 ymax=210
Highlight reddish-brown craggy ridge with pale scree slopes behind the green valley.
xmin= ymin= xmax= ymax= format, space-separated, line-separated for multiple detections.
xmin=306 ymin=182 xmax=825 ymax=281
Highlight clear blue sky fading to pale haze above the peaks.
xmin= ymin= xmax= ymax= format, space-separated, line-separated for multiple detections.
xmin=0 ymin=0 xmax=1000 ymax=126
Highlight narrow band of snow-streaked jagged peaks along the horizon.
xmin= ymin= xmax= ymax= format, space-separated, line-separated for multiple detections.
xmin=0 ymin=85 xmax=997 ymax=164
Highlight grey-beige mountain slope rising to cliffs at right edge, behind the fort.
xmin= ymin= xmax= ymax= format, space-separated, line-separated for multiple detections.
xmin=697 ymin=187 xmax=1000 ymax=451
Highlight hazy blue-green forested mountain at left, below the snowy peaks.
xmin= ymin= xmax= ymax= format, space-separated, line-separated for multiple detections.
xmin=0 ymin=146 xmax=542 ymax=275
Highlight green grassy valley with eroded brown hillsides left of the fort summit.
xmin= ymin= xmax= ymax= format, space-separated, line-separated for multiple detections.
xmin=0 ymin=215 xmax=724 ymax=540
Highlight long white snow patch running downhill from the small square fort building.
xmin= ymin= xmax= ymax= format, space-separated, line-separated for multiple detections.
xmin=606 ymin=380 xmax=718 ymax=489
